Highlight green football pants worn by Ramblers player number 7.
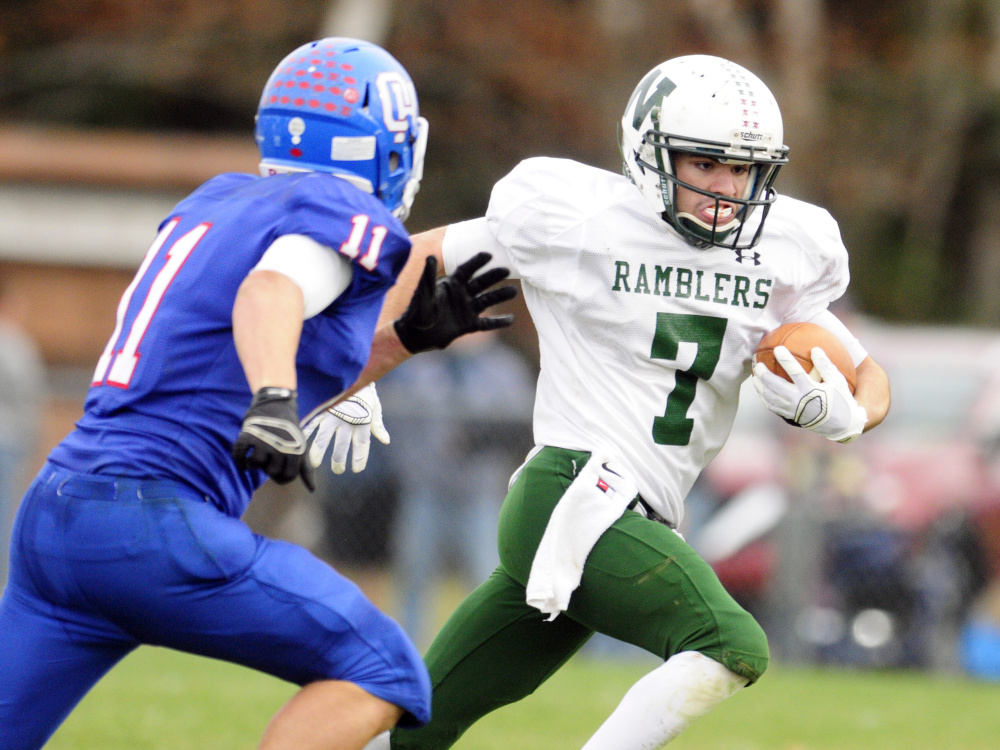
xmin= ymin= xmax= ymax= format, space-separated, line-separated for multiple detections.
xmin=392 ymin=448 xmax=768 ymax=750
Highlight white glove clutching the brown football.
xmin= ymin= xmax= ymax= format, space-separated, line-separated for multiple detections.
xmin=753 ymin=346 xmax=868 ymax=443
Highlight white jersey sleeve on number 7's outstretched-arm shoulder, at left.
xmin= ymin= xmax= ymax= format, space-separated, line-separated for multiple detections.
xmin=486 ymin=158 xmax=590 ymax=293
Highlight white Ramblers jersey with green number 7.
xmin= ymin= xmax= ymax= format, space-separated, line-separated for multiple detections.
xmin=445 ymin=158 xmax=863 ymax=523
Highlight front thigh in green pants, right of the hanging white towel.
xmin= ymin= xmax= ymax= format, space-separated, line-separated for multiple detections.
xmin=567 ymin=511 xmax=768 ymax=682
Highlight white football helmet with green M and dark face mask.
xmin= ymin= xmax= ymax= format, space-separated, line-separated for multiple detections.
xmin=619 ymin=55 xmax=788 ymax=250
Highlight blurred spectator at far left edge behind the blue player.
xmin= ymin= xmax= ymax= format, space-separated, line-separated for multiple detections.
xmin=0 ymin=281 xmax=45 ymax=589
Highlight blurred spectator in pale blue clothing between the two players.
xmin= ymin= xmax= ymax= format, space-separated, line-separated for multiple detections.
xmin=379 ymin=332 xmax=534 ymax=645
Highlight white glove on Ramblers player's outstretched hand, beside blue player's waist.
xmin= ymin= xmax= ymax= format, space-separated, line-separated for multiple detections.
xmin=302 ymin=383 xmax=389 ymax=474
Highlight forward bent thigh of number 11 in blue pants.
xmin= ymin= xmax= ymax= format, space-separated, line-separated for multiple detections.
xmin=100 ymin=500 xmax=430 ymax=721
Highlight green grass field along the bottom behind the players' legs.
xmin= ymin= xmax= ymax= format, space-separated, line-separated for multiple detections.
xmin=47 ymin=648 xmax=1000 ymax=750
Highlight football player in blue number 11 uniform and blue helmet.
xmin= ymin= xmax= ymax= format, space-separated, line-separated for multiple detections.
xmin=0 ymin=38 xmax=514 ymax=750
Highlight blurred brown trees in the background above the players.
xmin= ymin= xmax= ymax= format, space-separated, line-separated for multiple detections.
xmin=0 ymin=0 xmax=1000 ymax=326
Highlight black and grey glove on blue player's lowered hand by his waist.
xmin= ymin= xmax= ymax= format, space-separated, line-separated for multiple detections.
xmin=233 ymin=388 xmax=316 ymax=492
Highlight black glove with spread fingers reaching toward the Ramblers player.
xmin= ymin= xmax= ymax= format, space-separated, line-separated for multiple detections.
xmin=393 ymin=253 xmax=517 ymax=354
